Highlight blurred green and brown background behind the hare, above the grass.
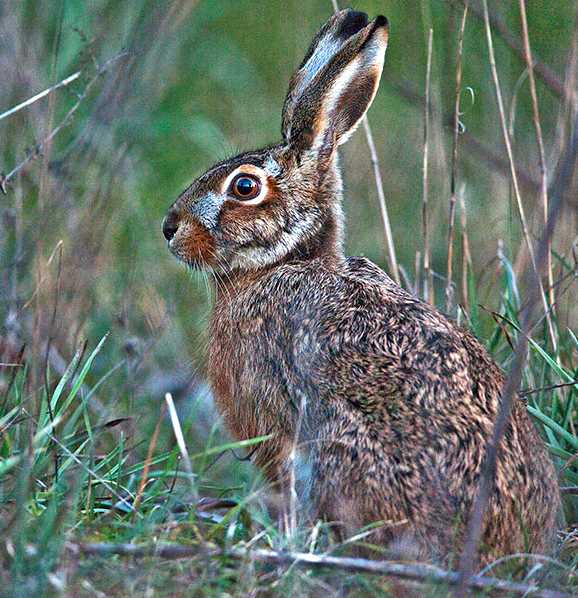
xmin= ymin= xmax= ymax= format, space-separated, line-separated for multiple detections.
xmin=0 ymin=0 xmax=577 ymax=492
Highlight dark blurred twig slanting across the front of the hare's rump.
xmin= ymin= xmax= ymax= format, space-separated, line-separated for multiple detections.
xmin=454 ymin=103 xmax=578 ymax=598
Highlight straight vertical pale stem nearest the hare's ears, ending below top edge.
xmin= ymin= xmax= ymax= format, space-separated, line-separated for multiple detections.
xmin=421 ymin=28 xmax=434 ymax=305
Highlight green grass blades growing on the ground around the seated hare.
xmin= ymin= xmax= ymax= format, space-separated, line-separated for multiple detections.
xmin=0 ymin=246 xmax=578 ymax=595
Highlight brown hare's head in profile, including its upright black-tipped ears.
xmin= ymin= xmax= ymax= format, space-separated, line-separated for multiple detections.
xmin=163 ymin=10 xmax=387 ymax=271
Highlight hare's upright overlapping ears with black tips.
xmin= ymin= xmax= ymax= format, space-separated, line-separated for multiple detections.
xmin=282 ymin=9 xmax=387 ymax=154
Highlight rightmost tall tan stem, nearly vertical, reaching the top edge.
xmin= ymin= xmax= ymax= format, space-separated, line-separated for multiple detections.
xmin=519 ymin=0 xmax=555 ymax=306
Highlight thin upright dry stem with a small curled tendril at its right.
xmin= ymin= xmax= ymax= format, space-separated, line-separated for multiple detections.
xmin=446 ymin=1 xmax=468 ymax=313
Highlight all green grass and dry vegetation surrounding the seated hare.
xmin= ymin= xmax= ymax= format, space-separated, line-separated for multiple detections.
xmin=0 ymin=0 xmax=578 ymax=596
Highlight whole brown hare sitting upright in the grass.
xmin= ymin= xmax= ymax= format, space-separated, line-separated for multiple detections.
xmin=163 ymin=10 xmax=560 ymax=562
